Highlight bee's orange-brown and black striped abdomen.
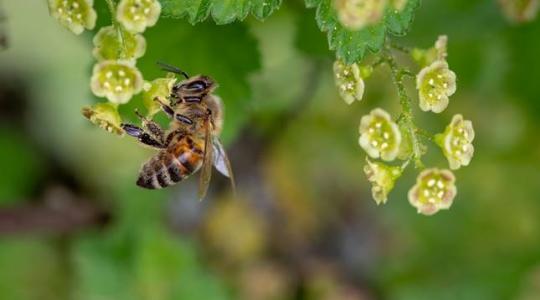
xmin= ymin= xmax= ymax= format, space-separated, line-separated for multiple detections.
xmin=137 ymin=137 xmax=203 ymax=189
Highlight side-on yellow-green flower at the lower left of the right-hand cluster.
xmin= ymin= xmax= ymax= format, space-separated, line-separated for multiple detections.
xmin=364 ymin=157 xmax=402 ymax=205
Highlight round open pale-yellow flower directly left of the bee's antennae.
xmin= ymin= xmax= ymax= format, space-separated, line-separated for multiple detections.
xmin=90 ymin=60 xmax=143 ymax=104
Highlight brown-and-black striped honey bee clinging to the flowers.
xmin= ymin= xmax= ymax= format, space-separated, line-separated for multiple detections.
xmin=121 ymin=63 xmax=234 ymax=199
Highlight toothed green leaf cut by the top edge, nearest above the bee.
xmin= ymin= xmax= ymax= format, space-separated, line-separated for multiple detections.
xmin=160 ymin=0 xmax=282 ymax=24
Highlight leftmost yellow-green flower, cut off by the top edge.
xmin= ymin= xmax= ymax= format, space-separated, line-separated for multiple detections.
xmin=49 ymin=0 xmax=97 ymax=34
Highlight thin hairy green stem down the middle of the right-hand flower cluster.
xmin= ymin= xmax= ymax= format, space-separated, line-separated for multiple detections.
xmin=382 ymin=51 xmax=424 ymax=168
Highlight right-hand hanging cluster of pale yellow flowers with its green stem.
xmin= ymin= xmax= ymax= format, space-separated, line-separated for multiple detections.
xmin=344 ymin=36 xmax=474 ymax=215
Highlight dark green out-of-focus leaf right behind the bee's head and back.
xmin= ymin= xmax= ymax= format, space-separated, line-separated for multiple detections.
xmin=136 ymin=19 xmax=260 ymax=143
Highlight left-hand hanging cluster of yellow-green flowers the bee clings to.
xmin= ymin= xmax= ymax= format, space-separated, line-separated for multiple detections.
xmin=59 ymin=0 xmax=161 ymax=135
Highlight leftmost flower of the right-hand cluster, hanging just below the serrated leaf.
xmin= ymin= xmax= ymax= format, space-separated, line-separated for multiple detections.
xmin=334 ymin=60 xmax=365 ymax=104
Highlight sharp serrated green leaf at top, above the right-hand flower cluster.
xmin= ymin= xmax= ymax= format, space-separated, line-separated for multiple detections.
xmin=306 ymin=0 xmax=420 ymax=64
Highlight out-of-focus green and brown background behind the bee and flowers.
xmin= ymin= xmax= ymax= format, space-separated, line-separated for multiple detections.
xmin=0 ymin=0 xmax=540 ymax=300
